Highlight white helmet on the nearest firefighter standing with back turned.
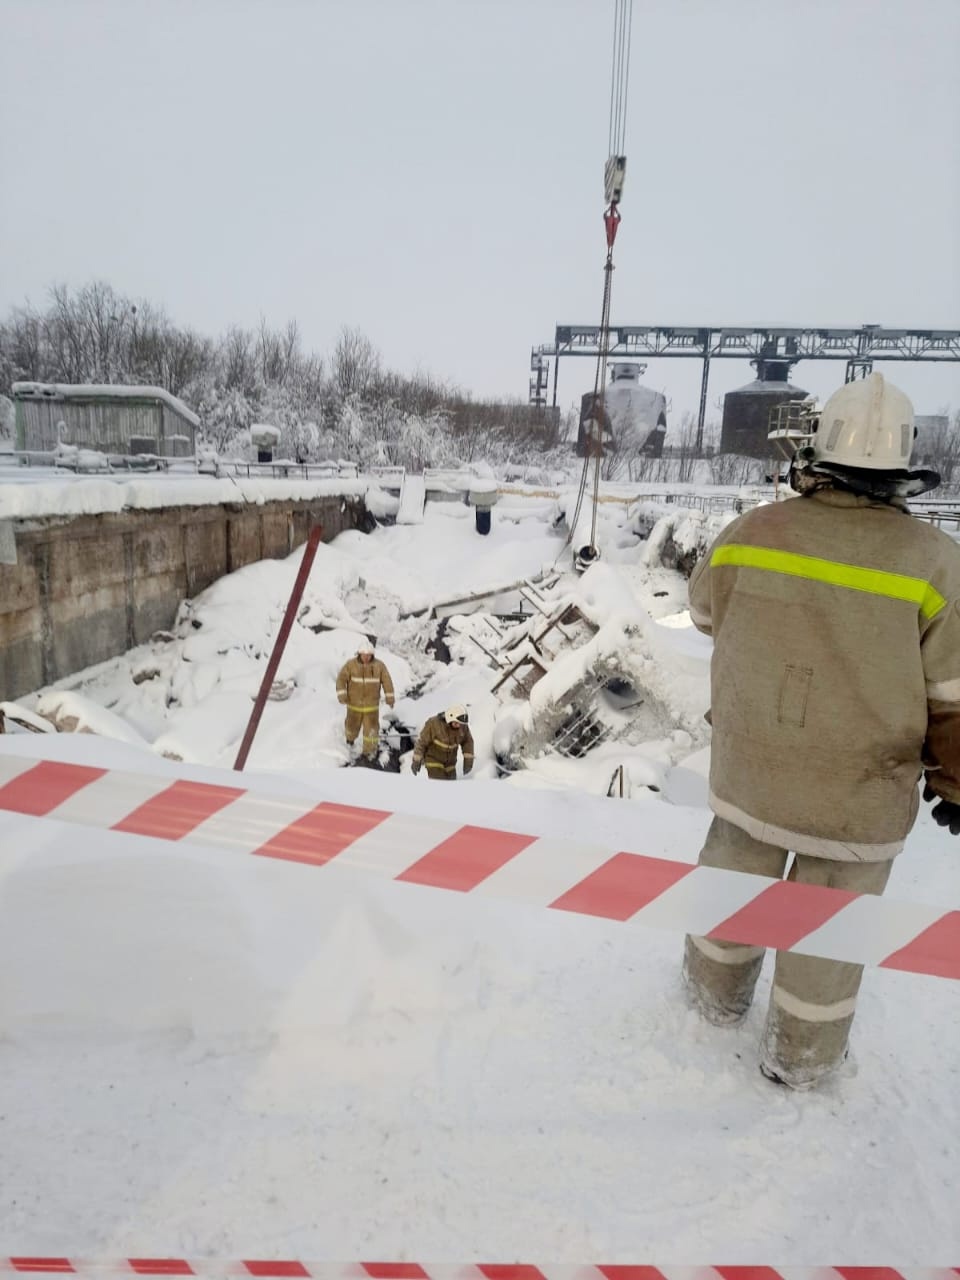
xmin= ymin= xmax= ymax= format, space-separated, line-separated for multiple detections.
xmin=808 ymin=374 xmax=914 ymax=471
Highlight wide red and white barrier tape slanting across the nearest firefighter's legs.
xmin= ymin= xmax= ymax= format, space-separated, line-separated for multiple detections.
xmin=0 ymin=755 xmax=960 ymax=978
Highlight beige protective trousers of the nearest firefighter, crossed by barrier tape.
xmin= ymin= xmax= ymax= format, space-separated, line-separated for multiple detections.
xmin=684 ymin=817 xmax=892 ymax=1088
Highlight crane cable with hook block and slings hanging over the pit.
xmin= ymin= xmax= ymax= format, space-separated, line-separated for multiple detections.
xmin=567 ymin=0 xmax=634 ymax=558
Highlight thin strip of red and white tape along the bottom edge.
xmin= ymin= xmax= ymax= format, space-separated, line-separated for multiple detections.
xmin=0 ymin=1257 xmax=960 ymax=1280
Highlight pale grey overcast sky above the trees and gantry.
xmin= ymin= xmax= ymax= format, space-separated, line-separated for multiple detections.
xmin=0 ymin=0 xmax=960 ymax=420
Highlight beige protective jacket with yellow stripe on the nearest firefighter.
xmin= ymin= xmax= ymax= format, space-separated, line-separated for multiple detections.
xmin=690 ymin=489 xmax=960 ymax=861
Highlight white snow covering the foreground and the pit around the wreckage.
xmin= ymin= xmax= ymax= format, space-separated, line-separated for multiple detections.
xmin=0 ymin=497 xmax=960 ymax=1266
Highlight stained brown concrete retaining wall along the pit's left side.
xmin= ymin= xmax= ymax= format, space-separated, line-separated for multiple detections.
xmin=0 ymin=495 xmax=366 ymax=700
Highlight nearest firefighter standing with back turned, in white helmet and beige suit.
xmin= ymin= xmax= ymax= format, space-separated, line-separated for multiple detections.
xmin=684 ymin=374 xmax=960 ymax=1088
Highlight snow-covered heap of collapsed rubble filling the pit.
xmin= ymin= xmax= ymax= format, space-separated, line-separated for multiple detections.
xmin=9 ymin=499 xmax=708 ymax=791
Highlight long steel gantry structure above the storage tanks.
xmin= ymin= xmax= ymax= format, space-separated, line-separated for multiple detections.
xmin=530 ymin=324 xmax=960 ymax=448
